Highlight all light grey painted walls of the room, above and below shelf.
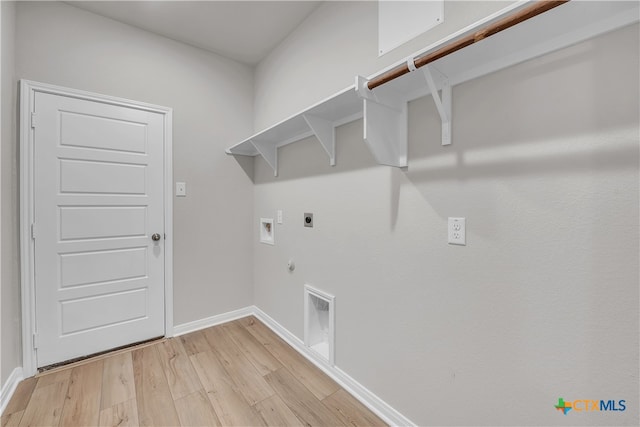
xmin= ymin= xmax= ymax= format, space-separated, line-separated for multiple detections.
xmin=1 ymin=2 xmax=640 ymax=425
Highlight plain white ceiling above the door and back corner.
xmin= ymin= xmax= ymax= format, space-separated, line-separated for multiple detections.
xmin=66 ymin=0 xmax=321 ymax=65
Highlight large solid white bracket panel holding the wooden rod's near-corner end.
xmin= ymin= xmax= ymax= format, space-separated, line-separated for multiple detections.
xmin=356 ymin=76 xmax=408 ymax=167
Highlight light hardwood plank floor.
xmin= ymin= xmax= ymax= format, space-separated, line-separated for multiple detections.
xmin=2 ymin=317 xmax=385 ymax=426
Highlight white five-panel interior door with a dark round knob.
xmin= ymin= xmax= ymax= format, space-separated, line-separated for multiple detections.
xmin=32 ymin=92 xmax=165 ymax=367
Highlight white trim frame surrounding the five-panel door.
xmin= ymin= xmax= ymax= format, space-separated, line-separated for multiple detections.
xmin=19 ymin=79 xmax=173 ymax=377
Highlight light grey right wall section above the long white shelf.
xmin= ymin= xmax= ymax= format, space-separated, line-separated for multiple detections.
xmin=255 ymin=0 xmax=513 ymax=130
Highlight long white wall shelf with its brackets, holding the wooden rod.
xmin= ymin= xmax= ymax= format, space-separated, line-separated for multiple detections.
xmin=227 ymin=0 xmax=640 ymax=175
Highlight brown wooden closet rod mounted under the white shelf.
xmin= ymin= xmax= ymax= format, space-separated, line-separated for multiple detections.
xmin=367 ymin=0 xmax=569 ymax=90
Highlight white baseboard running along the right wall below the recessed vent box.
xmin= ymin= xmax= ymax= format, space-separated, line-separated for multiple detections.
xmin=252 ymin=306 xmax=416 ymax=426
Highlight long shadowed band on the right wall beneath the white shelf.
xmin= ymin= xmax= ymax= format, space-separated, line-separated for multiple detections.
xmin=248 ymin=27 xmax=638 ymax=189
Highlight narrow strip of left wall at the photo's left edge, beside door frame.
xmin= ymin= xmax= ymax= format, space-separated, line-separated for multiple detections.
xmin=0 ymin=1 xmax=17 ymax=386
